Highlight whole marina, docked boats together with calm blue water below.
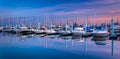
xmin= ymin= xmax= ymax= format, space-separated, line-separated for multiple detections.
xmin=0 ymin=19 xmax=120 ymax=59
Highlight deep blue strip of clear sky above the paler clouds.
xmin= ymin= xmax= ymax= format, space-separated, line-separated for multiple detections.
xmin=0 ymin=0 xmax=89 ymax=9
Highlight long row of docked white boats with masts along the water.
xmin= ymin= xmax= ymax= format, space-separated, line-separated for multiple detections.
xmin=0 ymin=18 xmax=120 ymax=38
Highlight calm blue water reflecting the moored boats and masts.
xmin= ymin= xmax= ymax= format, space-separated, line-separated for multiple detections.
xmin=0 ymin=33 xmax=120 ymax=59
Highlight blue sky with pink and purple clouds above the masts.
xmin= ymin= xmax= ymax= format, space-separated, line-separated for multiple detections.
xmin=0 ymin=0 xmax=120 ymax=22
